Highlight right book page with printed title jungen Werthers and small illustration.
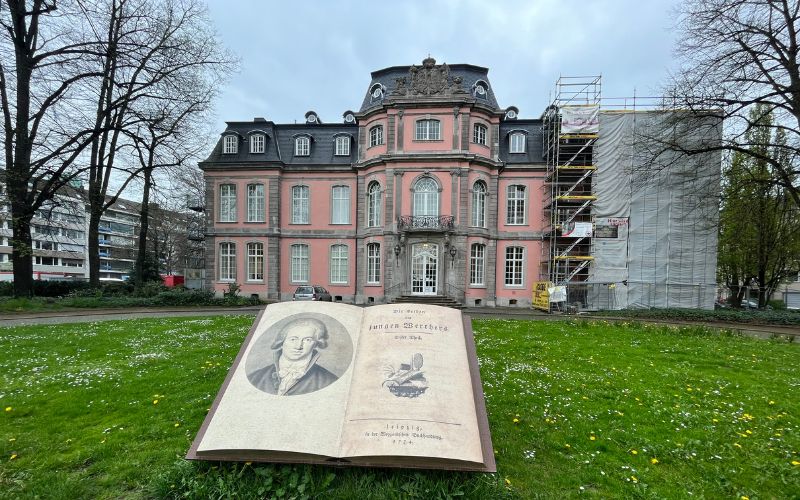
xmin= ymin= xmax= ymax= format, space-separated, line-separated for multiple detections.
xmin=341 ymin=304 xmax=483 ymax=463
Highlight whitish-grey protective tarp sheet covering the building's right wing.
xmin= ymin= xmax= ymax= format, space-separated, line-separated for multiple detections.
xmin=587 ymin=112 xmax=720 ymax=309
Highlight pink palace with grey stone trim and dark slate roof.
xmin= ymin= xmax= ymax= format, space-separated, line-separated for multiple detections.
xmin=200 ymin=58 xmax=546 ymax=307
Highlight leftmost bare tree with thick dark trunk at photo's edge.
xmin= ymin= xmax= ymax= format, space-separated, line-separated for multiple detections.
xmin=0 ymin=0 xmax=106 ymax=296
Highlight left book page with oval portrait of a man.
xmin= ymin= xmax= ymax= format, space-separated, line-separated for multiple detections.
xmin=197 ymin=302 xmax=364 ymax=457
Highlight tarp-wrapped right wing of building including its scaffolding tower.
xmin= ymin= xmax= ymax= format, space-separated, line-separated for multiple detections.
xmin=541 ymin=77 xmax=721 ymax=310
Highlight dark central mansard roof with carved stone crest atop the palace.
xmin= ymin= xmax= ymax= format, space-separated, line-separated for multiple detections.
xmin=360 ymin=57 xmax=499 ymax=113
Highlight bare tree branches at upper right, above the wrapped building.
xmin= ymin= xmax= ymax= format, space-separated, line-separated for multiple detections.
xmin=660 ymin=0 xmax=800 ymax=205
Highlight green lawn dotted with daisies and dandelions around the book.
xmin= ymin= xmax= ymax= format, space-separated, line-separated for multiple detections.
xmin=0 ymin=316 xmax=800 ymax=499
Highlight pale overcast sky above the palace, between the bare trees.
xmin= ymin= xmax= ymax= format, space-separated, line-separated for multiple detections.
xmin=203 ymin=0 xmax=677 ymax=127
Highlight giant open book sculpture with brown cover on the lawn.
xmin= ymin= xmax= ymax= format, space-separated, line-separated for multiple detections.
xmin=187 ymin=302 xmax=496 ymax=472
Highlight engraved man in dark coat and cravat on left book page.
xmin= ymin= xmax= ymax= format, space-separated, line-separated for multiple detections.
xmin=247 ymin=318 xmax=338 ymax=396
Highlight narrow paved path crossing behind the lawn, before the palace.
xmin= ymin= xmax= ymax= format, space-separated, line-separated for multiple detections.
xmin=0 ymin=306 xmax=800 ymax=338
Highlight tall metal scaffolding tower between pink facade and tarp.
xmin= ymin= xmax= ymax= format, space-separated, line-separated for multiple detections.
xmin=540 ymin=76 xmax=601 ymax=290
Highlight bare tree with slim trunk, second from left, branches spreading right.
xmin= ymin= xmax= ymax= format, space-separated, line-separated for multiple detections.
xmin=80 ymin=0 xmax=232 ymax=284
